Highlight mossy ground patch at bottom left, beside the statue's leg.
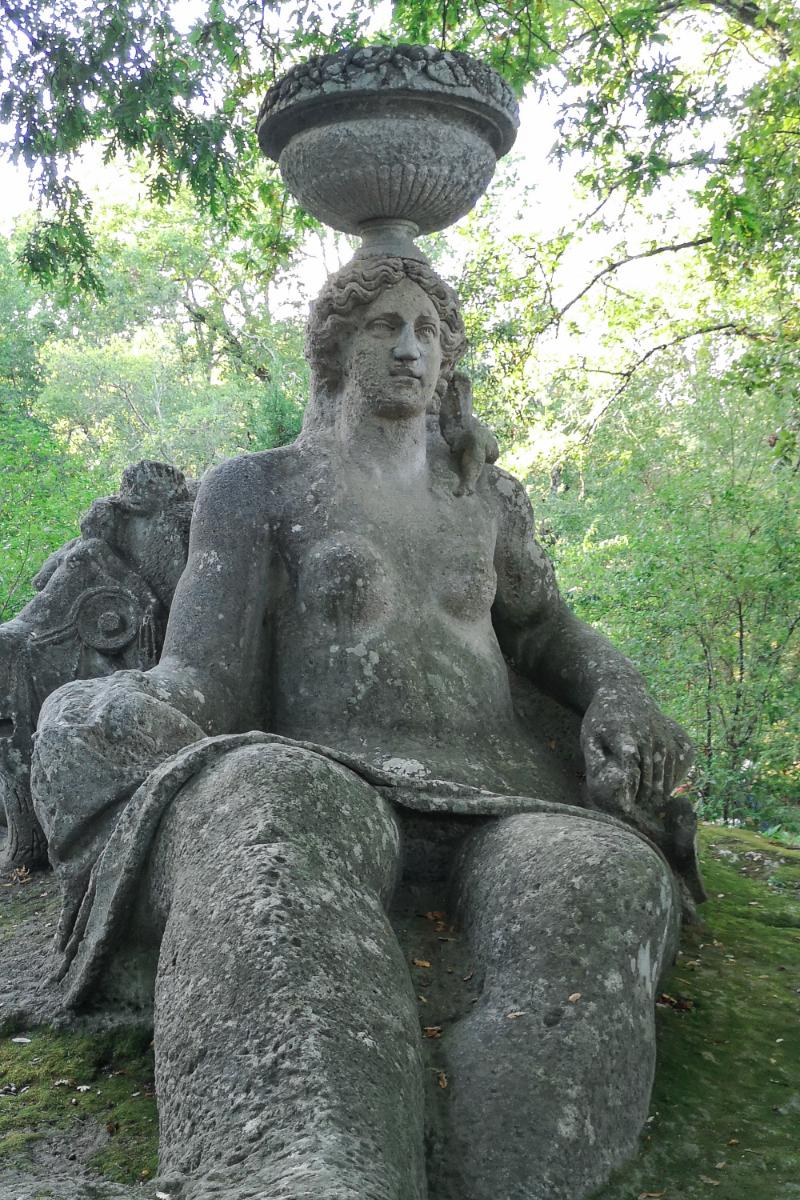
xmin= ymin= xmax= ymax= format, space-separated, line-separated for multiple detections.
xmin=0 ymin=1030 xmax=158 ymax=1183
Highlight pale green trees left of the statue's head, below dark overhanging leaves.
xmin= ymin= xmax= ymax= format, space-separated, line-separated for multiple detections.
xmin=0 ymin=187 xmax=307 ymax=619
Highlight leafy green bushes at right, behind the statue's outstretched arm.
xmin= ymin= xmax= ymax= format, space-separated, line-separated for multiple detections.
xmin=532 ymin=346 xmax=800 ymax=827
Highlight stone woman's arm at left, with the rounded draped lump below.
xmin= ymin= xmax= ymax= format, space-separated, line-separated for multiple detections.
xmin=31 ymin=455 xmax=270 ymax=854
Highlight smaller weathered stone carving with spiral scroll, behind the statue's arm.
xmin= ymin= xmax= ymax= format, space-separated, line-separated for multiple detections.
xmin=0 ymin=462 xmax=194 ymax=868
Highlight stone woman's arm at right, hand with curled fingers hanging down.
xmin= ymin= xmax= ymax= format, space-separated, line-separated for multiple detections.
xmin=493 ymin=472 xmax=692 ymax=811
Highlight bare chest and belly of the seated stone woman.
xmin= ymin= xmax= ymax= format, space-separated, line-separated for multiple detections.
xmin=248 ymin=443 xmax=563 ymax=791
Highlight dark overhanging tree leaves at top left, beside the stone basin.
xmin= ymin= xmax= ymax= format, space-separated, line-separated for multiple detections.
xmin=0 ymin=0 xmax=372 ymax=295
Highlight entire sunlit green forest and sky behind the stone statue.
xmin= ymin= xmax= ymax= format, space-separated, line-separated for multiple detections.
xmin=0 ymin=0 xmax=800 ymax=844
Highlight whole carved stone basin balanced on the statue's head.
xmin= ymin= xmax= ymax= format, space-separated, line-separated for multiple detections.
xmin=258 ymin=46 xmax=518 ymax=236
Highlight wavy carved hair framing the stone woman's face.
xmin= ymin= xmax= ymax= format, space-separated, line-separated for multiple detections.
xmin=306 ymin=256 xmax=467 ymax=426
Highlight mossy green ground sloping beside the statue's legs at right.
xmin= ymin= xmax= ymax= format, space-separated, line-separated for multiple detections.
xmin=595 ymin=826 xmax=800 ymax=1200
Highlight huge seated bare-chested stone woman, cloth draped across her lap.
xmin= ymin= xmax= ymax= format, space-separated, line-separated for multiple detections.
xmin=26 ymin=48 xmax=699 ymax=1200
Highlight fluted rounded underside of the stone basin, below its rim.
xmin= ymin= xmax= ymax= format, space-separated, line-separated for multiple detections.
xmin=279 ymin=106 xmax=497 ymax=234
